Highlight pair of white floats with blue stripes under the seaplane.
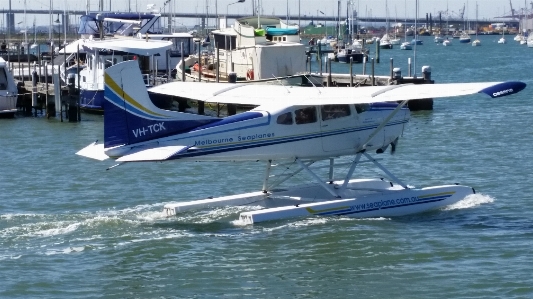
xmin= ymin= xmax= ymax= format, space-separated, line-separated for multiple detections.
xmin=164 ymin=179 xmax=474 ymax=224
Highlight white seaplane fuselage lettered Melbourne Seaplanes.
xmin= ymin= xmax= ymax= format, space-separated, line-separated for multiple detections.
xmin=105 ymin=103 xmax=409 ymax=161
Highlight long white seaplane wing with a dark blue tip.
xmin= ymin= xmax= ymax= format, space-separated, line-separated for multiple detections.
xmin=149 ymin=81 xmax=526 ymax=106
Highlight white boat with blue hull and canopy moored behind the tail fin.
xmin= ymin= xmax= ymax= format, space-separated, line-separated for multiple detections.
xmin=56 ymin=12 xmax=194 ymax=113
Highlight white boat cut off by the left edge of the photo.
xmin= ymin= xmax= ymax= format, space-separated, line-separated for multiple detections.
xmin=0 ymin=57 xmax=18 ymax=117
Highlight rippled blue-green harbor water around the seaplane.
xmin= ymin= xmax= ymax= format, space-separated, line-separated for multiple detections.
xmin=0 ymin=36 xmax=533 ymax=298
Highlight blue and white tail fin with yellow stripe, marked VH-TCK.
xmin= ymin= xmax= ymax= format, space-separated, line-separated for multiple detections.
xmin=104 ymin=60 xmax=220 ymax=148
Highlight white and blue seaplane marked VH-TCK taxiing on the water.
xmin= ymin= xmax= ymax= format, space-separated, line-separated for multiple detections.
xmin=77 ymin=61 xmax=526 ymax=225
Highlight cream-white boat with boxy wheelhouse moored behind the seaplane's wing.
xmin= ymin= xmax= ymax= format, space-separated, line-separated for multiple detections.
xmin=176 ymin=16 xmax=305 ymax=84
